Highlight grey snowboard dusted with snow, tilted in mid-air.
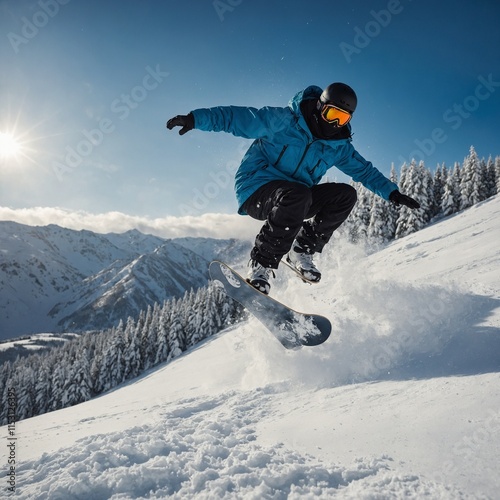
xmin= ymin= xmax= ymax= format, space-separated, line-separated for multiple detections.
xmin=209 ymin=261 xmax=332 ymax=349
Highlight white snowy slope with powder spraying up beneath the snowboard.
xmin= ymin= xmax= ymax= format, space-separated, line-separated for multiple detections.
xmin=1 ymin=196 xmax=500 ymax=499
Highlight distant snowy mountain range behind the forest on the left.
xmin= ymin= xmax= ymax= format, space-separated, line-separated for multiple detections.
xmin=0 ymin=221 xmax=250 ymax=340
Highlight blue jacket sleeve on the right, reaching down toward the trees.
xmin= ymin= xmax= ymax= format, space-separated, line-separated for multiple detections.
xmin=335 ymin=143 xmax=398 ymax=200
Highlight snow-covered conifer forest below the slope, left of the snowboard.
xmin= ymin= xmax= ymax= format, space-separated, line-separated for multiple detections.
xmin=0 ymin=284 xmax=243 ymax=425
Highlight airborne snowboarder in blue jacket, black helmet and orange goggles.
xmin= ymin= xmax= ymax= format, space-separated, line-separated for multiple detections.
xmin=167 ymin=83 xmax=420 ymax=294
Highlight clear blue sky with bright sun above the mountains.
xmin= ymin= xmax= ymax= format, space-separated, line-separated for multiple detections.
xmin=0 ymin=0 xmax=500 ymax=227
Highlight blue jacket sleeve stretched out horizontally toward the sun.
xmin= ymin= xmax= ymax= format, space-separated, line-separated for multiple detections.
xmin=191 ymin=106 xmax=291 ymax=139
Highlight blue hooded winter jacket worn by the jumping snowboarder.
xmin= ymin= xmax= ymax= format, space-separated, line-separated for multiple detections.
xmin=192 ymin=86 xmax=398 ymax=215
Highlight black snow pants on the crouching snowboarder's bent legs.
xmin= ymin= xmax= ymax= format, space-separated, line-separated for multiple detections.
xmin=243 ymin=181 xmax=357 ymax=269
